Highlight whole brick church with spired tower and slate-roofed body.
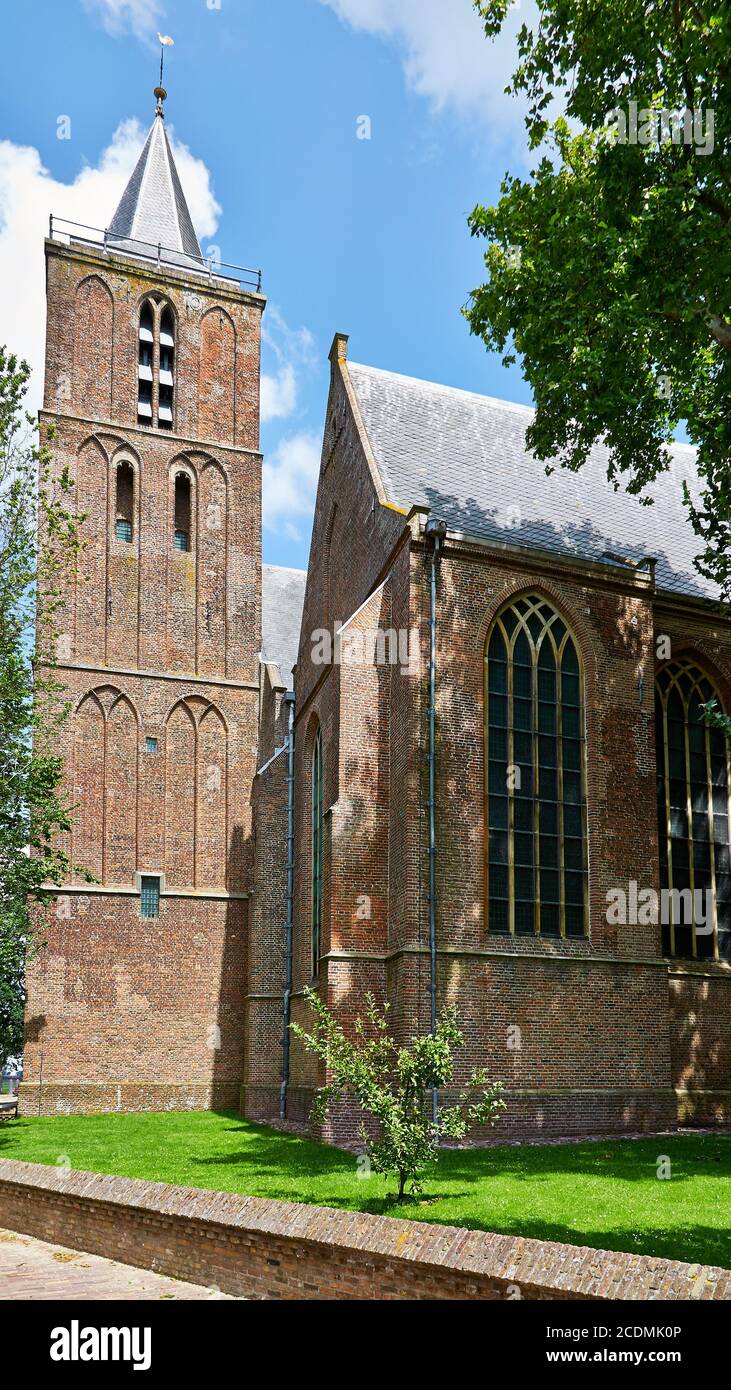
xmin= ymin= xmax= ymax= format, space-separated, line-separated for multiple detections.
xmin=21 ymin=88 xmax=731 ymax=1141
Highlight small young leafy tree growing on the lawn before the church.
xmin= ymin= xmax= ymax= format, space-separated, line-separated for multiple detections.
xmin=290 ymin=990 xmax=506 ymax=1201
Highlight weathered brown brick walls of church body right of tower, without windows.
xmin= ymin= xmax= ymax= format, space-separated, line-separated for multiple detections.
xmin=247 ymin=335 xmax=731 ymax=1140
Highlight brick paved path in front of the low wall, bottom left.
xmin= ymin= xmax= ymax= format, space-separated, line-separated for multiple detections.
xmin=0 ymin=1230 xmax=237 ymax=1300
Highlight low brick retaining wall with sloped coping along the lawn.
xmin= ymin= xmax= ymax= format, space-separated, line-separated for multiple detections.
xmin=0 ymin=1159 xmax=731 ymax=1300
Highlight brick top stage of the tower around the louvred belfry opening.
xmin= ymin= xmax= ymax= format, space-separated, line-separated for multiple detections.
xmin=43 ymin=240 xmax=264 ymax=450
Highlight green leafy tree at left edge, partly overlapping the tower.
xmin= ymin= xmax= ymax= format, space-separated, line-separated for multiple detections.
xmin=0 ymin=348 xmax=78 ymax=1065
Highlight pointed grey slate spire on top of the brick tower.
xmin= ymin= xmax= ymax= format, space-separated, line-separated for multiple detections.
xmin=107 ymin=88 xmax=206 ymax=270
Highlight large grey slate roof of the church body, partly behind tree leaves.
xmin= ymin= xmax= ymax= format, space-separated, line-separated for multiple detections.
xmin=347 ymin=363 xmax=717 ymax=598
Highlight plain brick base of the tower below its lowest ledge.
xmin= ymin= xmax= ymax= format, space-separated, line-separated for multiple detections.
xmin=21 ymin=892 xmax=246 ymax=1115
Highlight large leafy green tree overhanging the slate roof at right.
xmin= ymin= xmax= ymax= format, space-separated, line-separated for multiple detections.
xmin=466 ymin=0 xmax=731 ymax=599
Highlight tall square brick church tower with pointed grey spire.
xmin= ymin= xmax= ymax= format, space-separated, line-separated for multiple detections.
xmin=21 ymin=88 xmax=264 ymax=1113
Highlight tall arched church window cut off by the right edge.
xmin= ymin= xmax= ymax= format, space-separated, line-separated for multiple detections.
xmin=655 ymin=657 xmax=731 ymax=960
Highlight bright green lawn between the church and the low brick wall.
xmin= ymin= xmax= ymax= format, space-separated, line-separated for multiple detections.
xmin=0 ymin=1111 xmax=731 ymax=1268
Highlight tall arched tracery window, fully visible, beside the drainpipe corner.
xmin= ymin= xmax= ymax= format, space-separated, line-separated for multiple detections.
xmin=485 ymin=596 xmax=588 ymax=937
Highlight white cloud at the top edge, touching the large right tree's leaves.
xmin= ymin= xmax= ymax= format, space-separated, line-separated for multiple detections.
xmin=321 ymin=0 xmax=536 ymax=139
